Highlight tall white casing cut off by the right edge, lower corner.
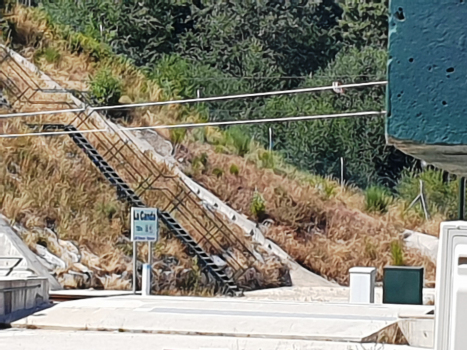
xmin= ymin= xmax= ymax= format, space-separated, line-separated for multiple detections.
xmin=435 ymin=221 xmax=467 ymax=350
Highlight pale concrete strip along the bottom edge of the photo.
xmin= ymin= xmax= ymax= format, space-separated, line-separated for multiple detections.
xmin=0 ymin=329 xmax=428 ymax=350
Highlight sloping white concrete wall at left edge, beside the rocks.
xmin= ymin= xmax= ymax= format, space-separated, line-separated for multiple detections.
xmin=0 ymin=216 xmax=62 ymax=290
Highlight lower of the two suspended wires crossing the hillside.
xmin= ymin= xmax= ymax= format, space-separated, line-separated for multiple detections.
xmin=0 ymin=111 xmax=386 ymax=138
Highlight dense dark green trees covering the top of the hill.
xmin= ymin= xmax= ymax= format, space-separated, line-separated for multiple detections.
xmin=34 ymin=0 xmax=413 ymax=187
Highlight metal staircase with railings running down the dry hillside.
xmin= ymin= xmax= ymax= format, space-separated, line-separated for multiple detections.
xmin=0 ymin=47 xmax=261 ymax=294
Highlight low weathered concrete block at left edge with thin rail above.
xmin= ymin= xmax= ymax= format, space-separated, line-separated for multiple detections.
xmin=0 ymin=277 xmax=50 ymax=324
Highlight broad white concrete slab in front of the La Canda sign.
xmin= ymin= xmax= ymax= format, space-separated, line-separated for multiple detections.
xmin=13 ymin=296 xmax=433 ymax=342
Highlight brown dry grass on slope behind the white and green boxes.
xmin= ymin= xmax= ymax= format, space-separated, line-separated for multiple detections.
xmin=179 ymin=143 xmax=435 ymax=285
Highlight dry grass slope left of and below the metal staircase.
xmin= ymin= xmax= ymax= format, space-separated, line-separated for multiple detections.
xmin=0 ymin=116 xmax=212 ymax=293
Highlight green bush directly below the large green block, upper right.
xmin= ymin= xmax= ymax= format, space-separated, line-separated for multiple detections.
xmin=396 ymin=169 xmax=459 ymax=219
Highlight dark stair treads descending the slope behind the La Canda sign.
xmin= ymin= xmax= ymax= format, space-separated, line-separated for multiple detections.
xmin=37 ymin=124 xmax=241 ymax=295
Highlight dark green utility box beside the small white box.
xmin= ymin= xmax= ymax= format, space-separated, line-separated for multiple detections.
xmin=383 ymin=266 xmax=424 ymax=305
